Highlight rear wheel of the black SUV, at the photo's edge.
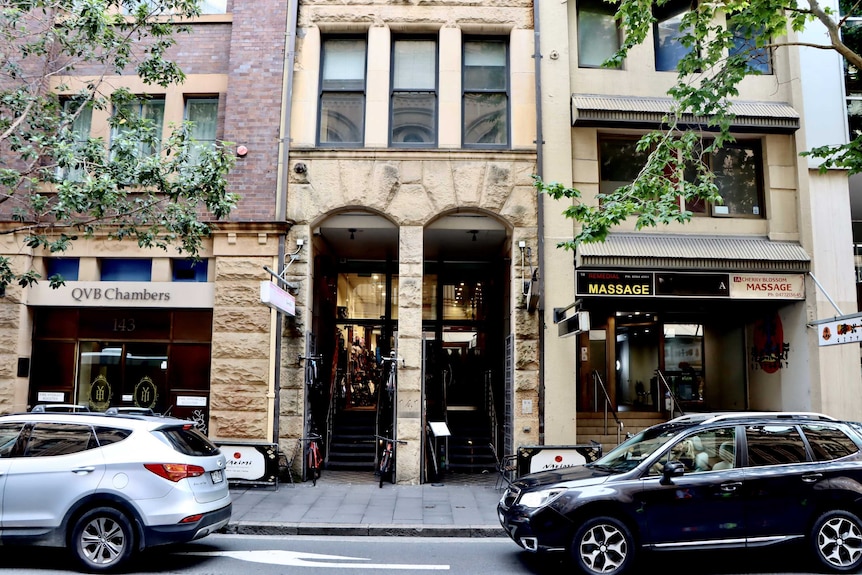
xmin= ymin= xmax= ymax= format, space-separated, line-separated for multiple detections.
xmin=811 ymin=511 xmax=862 ymax=572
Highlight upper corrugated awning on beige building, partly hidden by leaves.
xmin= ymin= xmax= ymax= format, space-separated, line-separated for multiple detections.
xmin=572 ymin=94 xmax=799 ymax=133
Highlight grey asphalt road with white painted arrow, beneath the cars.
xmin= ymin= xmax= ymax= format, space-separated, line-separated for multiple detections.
xmin=0 ymin=535 xmax=844 ymax=575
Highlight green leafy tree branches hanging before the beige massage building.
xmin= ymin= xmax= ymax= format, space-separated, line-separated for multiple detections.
xmin=534 ymin=0 xmax=862 ymax=249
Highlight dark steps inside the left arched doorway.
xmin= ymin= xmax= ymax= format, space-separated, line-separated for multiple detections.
xmin=326 ymin=409 xmax=376 ymax=471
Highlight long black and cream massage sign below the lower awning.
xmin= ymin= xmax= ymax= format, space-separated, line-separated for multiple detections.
xmin=576 ymin=270 xmax=805 ymax=299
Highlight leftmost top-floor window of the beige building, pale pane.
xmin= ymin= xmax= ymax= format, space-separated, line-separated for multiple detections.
xmin=578 ymin=0 xmax=620 ymax=68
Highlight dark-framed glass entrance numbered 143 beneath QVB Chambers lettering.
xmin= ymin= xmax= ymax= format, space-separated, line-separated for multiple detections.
xmin=29 ymin=308 xmax=212 ymax=431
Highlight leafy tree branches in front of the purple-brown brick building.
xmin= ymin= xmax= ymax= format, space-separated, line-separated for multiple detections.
xmin=0 ymin=0 xmax=236 ymax=287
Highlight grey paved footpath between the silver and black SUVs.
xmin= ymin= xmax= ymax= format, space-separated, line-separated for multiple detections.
xmin=222 ymin=471 xmax=505 ymax=537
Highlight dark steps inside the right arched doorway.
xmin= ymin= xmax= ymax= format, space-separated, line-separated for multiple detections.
xmin=446 ymin=406 xmax=497 ymax=473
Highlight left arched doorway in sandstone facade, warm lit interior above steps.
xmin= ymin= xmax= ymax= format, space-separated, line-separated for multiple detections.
xmin=304 ymin=209 xmax=398 ymax=472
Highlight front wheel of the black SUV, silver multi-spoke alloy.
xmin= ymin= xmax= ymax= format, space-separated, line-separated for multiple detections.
xmin=571 ymin=517 xmax=635 ymax=575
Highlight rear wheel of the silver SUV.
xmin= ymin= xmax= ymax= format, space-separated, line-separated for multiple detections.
xmin=70 ymin=507 xmax=135 ymax=572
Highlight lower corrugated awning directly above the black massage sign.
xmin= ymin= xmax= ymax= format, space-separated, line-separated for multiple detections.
xmin=576 ymin=233 xmax=811 ymax=273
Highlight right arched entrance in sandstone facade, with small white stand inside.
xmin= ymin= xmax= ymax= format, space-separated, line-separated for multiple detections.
xmin=422 ymin=212 xmax=511 ymax=481
